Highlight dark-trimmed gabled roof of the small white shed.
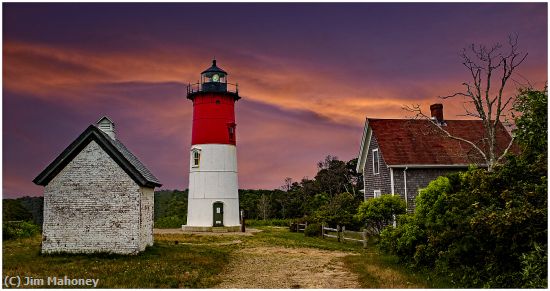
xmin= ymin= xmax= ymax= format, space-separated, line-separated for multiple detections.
xmin=33 ymin=125 xmax=162 ymax=187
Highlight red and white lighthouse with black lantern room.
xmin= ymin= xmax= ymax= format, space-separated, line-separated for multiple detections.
xmin=182 ymin=60 xmax=240 ymax=231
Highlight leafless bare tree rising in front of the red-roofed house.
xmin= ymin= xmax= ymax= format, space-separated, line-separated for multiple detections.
xmin=404 ymin=35 xmax=527 ymax=171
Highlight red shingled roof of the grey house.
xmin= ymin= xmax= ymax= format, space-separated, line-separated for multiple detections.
xmin=360 ymin=118 xmax=518 ymax=167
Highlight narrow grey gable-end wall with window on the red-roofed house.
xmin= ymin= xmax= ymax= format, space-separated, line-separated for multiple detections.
xmin=363 ymin=134 xmax=391 ymax=200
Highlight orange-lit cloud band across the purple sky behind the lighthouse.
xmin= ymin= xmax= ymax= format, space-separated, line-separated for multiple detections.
xmin=4 ymin=41 xmax=544 ymax=135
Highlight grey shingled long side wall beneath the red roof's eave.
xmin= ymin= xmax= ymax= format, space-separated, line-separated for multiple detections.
xmin=393 ymin=168 xmax=461 ymax=212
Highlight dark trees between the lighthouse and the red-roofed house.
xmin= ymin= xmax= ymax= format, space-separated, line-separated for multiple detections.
xmin=239 ymin=155 xmax=363 ymax=224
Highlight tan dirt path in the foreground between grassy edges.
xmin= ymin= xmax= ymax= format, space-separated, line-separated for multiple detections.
xmin=216 ymin=247 xmax=360 ymax=289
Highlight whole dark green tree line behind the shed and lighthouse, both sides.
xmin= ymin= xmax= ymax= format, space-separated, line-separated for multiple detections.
xmin=3 ymin=155 xmax=363 ymax=232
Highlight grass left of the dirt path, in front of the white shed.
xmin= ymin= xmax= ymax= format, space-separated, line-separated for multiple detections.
xmin=3 ymin=236 xmax=230 ymax=288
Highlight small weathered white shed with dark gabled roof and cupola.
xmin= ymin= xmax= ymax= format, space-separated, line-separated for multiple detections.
xmin=33 ymin=117 xmax=161 ymax=254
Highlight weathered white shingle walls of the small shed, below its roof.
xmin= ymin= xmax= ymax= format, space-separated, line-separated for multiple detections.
xmin=42 ymin=141 xmax=153 ymax=254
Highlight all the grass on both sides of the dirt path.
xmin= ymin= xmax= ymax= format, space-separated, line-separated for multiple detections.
xmin=3 ymin=227 xmax=453 ymax=288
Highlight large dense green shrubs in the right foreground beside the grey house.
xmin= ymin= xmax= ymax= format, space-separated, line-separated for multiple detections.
xmin=380 ymin=157 xmax=547 ymax=288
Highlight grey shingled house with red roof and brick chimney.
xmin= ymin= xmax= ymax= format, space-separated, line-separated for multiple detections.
xmin=357 ymin=104 xmax=511 ymax=212
